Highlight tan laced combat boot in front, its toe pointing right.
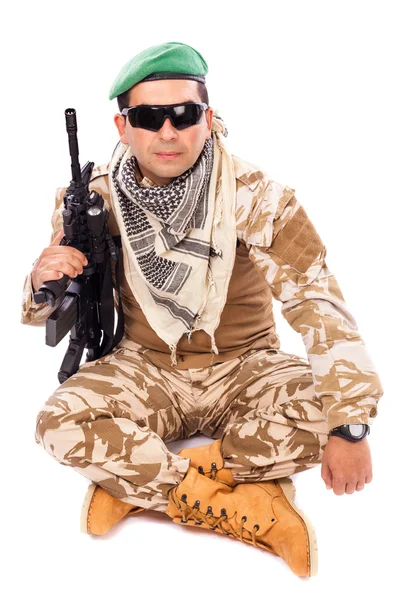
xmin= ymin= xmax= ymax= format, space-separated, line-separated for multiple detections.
xmin=166 ymin=467 xmax=318 ymax=577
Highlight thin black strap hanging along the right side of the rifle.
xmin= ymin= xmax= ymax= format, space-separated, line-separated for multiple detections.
xmin=99 ymin=238 xmax=124 ymax=357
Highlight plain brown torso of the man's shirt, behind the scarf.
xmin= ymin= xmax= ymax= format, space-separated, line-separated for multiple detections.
xmin=64 ymin=165 xmax=280 ymax=369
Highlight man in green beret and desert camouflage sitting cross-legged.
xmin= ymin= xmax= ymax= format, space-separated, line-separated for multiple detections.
xmin=22 ymin=42 xmax=383 ymax=576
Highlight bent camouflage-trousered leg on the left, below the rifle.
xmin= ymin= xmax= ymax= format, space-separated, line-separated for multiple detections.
xmin=35 ymin=348 xmax=190 ymax=512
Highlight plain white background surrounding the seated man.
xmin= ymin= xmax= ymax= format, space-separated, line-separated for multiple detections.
xmin=1 ymin=0 xmax=400 ymax=600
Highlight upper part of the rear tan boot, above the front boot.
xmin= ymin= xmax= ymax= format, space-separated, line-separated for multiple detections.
xmin=178 ymin=440 xmax=236 ymax=487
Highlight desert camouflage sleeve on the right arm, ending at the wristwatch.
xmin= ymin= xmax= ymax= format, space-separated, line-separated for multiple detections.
xmin=236 ymin=159 xmax=383 ymax=429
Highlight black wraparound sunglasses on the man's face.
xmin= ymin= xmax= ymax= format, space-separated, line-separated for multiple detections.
xmin=121 ymin=102 xmax=208 ymax=131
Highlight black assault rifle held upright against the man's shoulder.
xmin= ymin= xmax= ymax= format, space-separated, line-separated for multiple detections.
xmin=34 ymin=108 xmax=124 ymax=383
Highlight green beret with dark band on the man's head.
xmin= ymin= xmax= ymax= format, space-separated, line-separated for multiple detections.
xmin=109 ymin=42 xmax=208 ymax=100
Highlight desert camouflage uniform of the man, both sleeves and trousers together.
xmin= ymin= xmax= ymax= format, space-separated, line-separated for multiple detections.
xmin=21 ymin=152 xmax=383 ymax=510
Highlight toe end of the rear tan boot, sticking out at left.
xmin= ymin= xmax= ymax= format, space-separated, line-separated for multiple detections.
xmin=81 ymin=483 xmax=146 ymax=535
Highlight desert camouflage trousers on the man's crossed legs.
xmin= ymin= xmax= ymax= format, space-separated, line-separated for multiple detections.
xmin=35 ymin=340 xmax=328 ymax=512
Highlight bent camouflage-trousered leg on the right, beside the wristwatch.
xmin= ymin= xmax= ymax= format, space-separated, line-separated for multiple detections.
xmin=194 ymin=350 xmax=329 ymax=483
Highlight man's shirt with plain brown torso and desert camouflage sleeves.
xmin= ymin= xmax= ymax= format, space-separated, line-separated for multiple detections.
xmin=21 ymin=156 xmax=383 ymax=428
